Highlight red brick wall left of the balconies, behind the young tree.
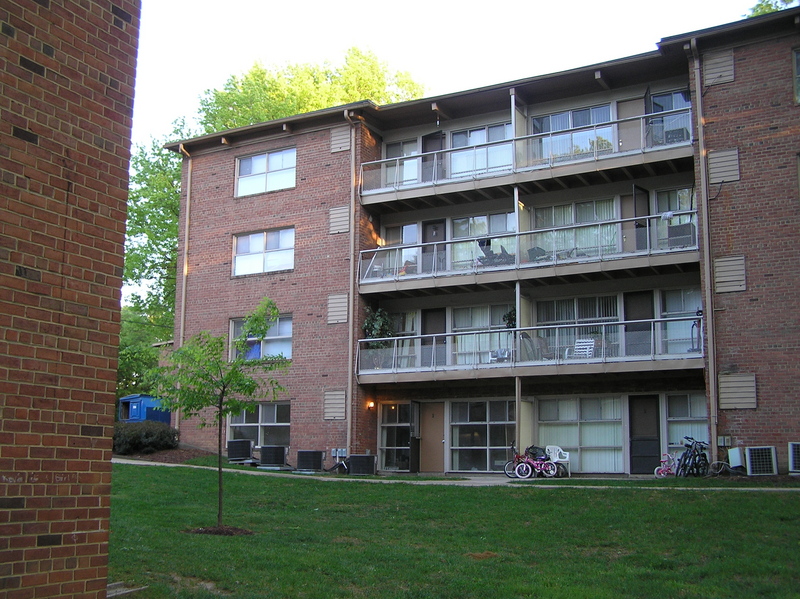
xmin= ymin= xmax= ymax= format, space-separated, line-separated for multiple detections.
xmin=176 ymin=122 xmax=360 ymax=463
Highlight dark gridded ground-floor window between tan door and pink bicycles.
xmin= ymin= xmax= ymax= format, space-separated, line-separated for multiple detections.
xmin=450 ymin=400 xmax=516 ymax=472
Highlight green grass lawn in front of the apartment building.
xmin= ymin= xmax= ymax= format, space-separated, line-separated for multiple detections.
xmin=109 ymin=464 xmax=800 ymax=599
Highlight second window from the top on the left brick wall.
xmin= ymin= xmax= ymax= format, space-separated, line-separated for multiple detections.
xmin=233 ymin=228 xmax=294 ymax=276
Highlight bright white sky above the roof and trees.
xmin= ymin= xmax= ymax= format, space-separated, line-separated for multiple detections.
xmin=133 ymin=0 xmax=757 ymax=145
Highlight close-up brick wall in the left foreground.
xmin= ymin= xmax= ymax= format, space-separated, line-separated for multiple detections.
xmin=0 ymin=0 xmax=140 ymax=599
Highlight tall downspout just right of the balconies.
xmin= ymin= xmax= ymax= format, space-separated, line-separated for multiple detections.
xmin=690 ymin=38 xmax=718 ymax=461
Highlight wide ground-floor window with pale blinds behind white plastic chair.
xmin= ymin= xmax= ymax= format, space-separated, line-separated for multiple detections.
xmin=538 ymin=397 xmax=624 ymax=472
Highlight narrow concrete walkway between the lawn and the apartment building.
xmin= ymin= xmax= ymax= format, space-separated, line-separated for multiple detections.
xmin=111 ymin=458 xmax=800 ymax=493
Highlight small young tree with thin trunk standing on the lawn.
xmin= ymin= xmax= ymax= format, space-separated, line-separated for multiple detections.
xmin=155 ymin=298 xmax=289 ymax=528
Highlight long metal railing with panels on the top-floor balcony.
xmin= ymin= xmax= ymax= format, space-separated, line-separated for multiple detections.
xmin=361 ymin=109 xmax=692 ymax=196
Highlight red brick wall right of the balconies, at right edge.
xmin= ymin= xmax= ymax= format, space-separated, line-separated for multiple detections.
xmin=703 ymin=35 xmax=800 ymax=472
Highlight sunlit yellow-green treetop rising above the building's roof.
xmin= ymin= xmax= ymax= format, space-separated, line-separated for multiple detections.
xmin=199 ymin=48 xmax=423 ymax=133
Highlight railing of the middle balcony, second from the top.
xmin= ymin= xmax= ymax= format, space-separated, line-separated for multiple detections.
xmin=358 ymin=211 xmax=697 ymax=286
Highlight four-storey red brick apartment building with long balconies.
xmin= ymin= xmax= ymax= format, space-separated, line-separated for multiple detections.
xmin=170 ymin=10 xmax=800 ymax=473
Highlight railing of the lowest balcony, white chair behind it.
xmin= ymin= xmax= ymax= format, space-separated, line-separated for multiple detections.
xmin=357 ymin=316 xmax=703 ymax=382
